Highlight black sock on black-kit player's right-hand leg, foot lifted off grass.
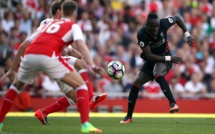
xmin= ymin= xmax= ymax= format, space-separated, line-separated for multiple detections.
xmin=156 ymin=75 xmax=175 ymax=105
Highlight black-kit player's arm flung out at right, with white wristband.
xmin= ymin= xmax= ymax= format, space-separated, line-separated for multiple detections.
xmin=173 ymin=16 xmax=194 ymax=47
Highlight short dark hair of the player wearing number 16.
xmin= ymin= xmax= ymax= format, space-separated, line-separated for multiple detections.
xmin=61 ymin=1 xmax=78 ymax=16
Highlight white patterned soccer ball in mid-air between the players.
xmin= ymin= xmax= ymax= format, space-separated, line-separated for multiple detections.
xmin=106 ymin=61 xmax=125 ymax=79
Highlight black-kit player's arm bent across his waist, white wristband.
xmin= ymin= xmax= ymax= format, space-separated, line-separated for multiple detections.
xmin=141 ymin=45 xmax=182 ymax=64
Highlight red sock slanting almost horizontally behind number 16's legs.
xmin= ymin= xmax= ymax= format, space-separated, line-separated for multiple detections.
xmin=41 ymin=96 xmax=74 ymax=115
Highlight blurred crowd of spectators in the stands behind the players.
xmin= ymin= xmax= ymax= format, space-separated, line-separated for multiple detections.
xmin=0 ymin=0 xmax=215 ymax=99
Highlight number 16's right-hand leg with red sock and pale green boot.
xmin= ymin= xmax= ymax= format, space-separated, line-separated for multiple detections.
xmin=61 ymin=70 xmax=102 ymax=132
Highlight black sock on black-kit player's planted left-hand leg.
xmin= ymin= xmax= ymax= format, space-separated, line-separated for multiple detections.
xmin=127 ymin=85 xmax=140 ymax=118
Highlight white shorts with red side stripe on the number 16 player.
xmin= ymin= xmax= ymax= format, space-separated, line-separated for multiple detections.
xmin=18 ymin=54 xmax=76 ymax=93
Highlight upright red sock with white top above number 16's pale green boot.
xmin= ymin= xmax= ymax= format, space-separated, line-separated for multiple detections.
xmin=76 ymin=85 xmax=90 ymax=124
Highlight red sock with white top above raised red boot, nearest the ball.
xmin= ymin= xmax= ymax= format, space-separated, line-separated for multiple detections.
xmin=79 ymin=69 xmax=94 ymax=100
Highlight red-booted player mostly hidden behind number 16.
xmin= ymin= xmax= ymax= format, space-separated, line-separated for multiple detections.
xmin=27 ymin=3 xmax=107 ymax=125
